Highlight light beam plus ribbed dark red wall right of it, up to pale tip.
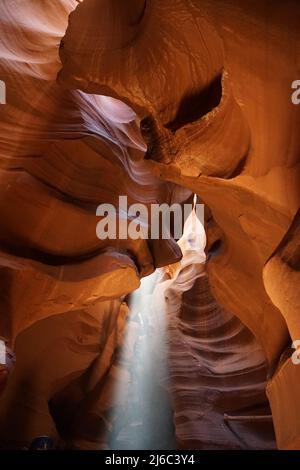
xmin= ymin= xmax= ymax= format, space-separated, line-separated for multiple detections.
xmin=105 ymin=214 xmax=276 ymax=449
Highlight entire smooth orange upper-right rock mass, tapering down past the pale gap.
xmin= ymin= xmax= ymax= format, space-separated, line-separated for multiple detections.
xmin=59 ymin=0 xmax=299 ymax=368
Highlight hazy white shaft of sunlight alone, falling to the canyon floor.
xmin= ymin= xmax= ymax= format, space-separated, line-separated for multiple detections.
xmin=109 ymin=272 xmax=176 ymax=450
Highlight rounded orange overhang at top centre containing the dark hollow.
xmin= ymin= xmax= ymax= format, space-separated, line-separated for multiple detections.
xmin=58 ymin=0 xmax=249 ymax=177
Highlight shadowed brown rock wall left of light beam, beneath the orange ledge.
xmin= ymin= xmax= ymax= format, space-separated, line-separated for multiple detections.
xmin=0 ymin=301 xmax=127 ymax=448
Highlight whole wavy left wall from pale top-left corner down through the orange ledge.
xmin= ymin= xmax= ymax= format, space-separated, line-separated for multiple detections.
xmin=0 ymin=0 xmax=185 ymax=343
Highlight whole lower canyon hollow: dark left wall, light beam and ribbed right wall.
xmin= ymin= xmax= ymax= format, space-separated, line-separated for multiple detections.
xmin=0 ymin=210 xmax=276 ymax=450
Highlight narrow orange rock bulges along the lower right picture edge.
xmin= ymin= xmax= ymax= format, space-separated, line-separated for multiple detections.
xmin=264 ymin=211 xmax=300 ymax=449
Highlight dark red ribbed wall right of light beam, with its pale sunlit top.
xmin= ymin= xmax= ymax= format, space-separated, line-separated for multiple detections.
xmin=158 ymin=222 xmax=275 ymax=449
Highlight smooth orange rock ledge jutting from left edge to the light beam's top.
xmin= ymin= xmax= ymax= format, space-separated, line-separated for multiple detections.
xmin=0 ymin=251 xmax=139 ymax=344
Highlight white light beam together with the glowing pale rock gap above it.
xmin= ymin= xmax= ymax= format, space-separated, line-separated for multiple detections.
xmin=109 ymin=201 xmax=206 ymax=450
